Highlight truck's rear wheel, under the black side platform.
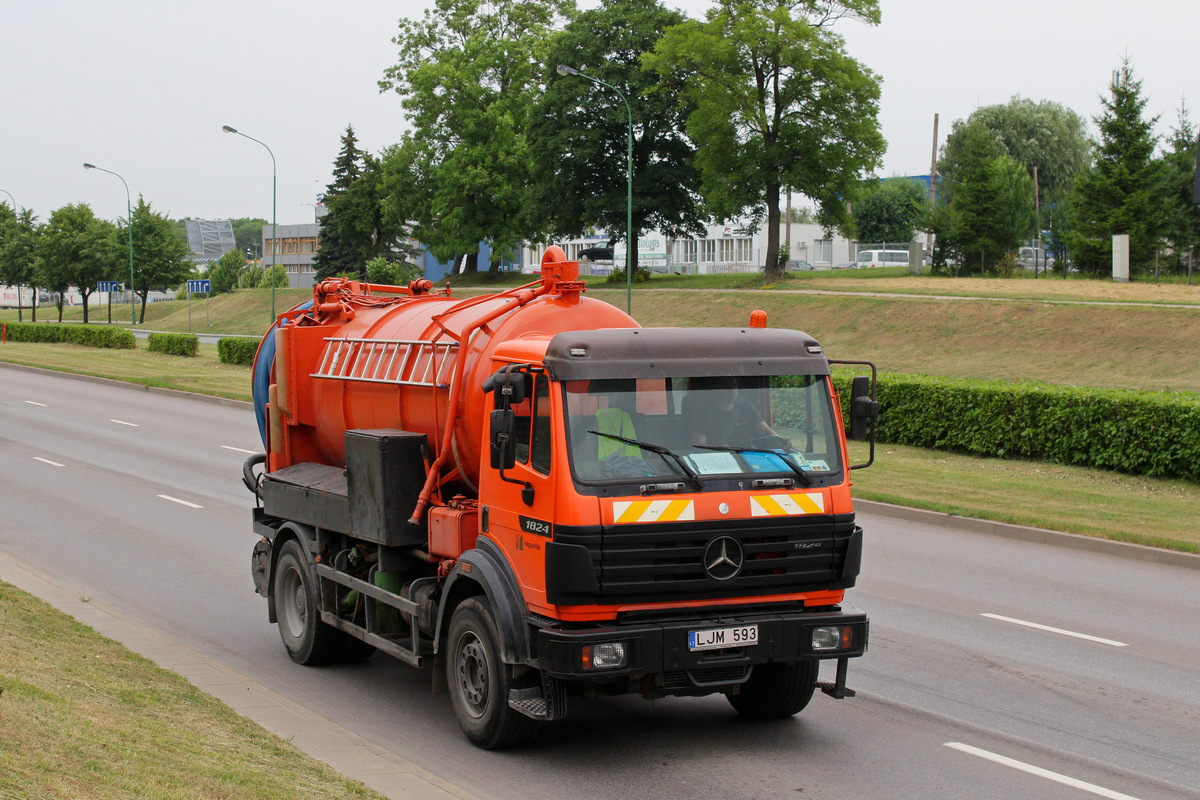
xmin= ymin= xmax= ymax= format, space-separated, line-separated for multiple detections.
xmin=275 ymin=539 xmax=341 ymax=666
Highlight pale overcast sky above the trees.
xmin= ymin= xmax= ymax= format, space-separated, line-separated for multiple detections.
xmin=0 ymin=0 xmax=1200 ymax=224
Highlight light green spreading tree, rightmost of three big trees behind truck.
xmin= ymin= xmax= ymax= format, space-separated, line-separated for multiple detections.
xmin=644 ymin=0 xmax=884 ymax=273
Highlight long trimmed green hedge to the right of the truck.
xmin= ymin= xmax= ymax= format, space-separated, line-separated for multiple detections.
xmin=836 ymin=373 xmax=1200 ymax=481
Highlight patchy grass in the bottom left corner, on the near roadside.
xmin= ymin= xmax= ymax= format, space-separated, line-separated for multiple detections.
xmin=0 ymin=583 xmax=382 ymax=800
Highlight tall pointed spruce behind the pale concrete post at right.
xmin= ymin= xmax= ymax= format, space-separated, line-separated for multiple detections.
xmin=1068 ymin=59 xmax=1166 ymax=276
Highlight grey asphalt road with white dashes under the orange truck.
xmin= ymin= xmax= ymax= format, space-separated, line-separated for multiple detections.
xmin=0 ymin=369 xmax=1200 ymax=800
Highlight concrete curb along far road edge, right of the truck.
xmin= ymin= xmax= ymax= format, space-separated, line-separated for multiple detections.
xmin=854 ymin=499 xmax=1200 ymax=570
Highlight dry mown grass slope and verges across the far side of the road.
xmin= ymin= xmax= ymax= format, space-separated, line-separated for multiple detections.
xmin=0 ymin=270 xmax=1200 ymax=552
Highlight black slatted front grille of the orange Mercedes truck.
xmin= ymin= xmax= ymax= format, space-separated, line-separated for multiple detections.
xmin=554 ymin=513 xmax=857 ymax=603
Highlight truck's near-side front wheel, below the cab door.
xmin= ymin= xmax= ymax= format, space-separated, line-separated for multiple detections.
xmin=445 ymin=597 xmax=540 ymax=750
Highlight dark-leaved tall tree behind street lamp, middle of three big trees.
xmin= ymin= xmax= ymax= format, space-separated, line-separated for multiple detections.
xmin=528 ymin=0 xmax=706 ymax=266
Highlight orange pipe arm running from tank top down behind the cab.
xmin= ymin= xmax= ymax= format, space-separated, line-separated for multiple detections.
xmin=408 ymin=245 xmax=578 ymax=525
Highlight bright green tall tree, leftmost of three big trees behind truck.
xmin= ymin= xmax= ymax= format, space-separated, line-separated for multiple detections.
xmin=379 ymin=0 xmax=574 ymax=271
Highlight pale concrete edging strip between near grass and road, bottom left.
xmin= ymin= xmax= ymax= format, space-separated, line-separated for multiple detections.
xmin=0 ymin=551 xmax=479 ymax=800
